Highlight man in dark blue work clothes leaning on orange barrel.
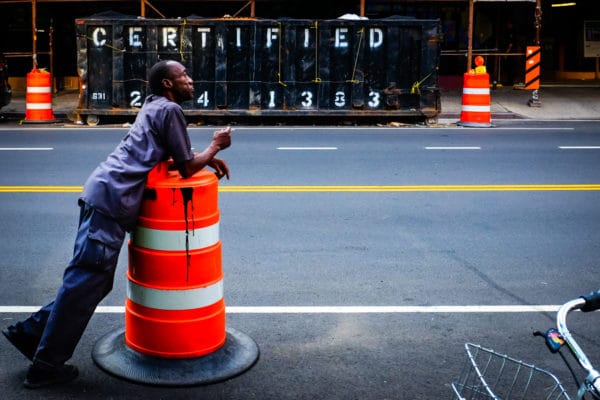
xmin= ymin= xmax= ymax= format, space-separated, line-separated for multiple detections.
xmin=2 ymin=61 xmax=231 ymax=388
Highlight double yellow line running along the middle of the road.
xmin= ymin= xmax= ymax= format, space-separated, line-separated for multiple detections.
xmin=0 ymin=184 xmax=600 ymax=193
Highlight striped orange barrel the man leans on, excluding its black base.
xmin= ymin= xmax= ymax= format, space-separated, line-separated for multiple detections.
xmin=125 ymin=164 xmax=225 ymax=358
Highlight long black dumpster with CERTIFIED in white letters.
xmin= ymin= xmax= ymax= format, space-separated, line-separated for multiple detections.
xmin=76 ymin=16 xmax=441 ymax=122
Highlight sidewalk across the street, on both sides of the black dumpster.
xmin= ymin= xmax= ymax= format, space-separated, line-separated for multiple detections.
xmin=0 ymin=83 xmax=600 ymax=123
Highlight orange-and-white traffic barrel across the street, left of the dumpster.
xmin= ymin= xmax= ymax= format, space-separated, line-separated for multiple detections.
xmin=25 ymin=68 xmax=55 ymax=123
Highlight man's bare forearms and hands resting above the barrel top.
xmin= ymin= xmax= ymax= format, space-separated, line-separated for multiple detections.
xmin=177 ymin=127 xmax=231 ymax=179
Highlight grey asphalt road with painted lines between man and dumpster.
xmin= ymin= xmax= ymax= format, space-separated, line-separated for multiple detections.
xmin=0 ymin=121 xmax=600 ymax=399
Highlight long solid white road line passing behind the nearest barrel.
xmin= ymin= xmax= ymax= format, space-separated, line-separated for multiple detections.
xmin=0 ymin=305 xmax=560 ymax=314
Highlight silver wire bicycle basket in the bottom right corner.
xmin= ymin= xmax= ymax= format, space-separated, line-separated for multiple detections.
xmin=452 ymin=343 xmax=570 ymax=400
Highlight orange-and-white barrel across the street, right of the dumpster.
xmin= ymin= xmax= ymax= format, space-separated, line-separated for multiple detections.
xmin=458 ymin=68 xmax=492 ymax=127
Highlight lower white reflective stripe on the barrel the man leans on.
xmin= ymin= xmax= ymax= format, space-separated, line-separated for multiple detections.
xmin=127 ymin=280 xmax=223 ymax=310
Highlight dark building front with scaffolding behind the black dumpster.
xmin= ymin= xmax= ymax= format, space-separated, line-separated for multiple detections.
xmin=0 ymin=0 xmax=600 ymax=90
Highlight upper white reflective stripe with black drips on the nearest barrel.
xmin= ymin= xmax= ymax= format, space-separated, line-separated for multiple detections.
xmin=131 ymin=222 xmax=219 ymax=251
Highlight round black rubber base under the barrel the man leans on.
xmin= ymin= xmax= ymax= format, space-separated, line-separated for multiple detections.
xmin=92 ymin=328 xmax=259 ymax=386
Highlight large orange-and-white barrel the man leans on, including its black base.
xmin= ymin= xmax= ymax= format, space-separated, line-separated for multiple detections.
xmin=92 ymin=162 xmax=259 ymax=386
